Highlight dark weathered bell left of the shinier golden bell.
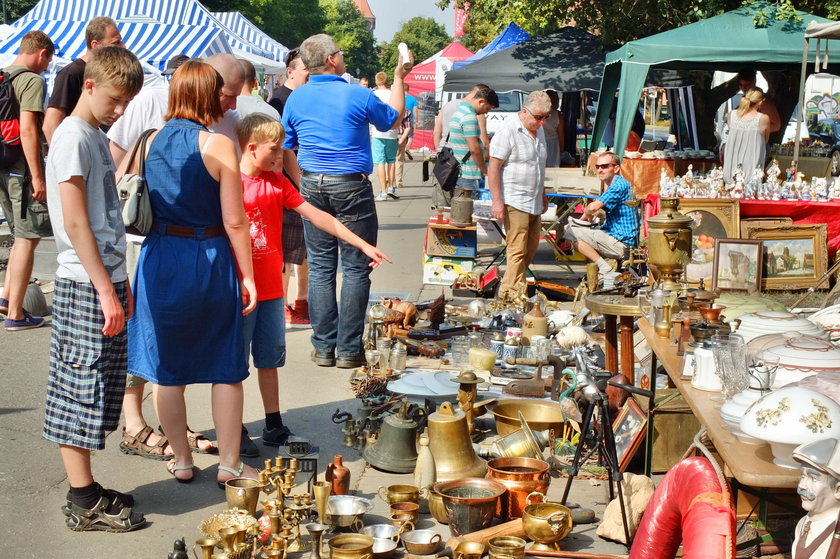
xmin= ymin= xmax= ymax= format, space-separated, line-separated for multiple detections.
xmin=362 ymin=402 xmax=417 ymax=474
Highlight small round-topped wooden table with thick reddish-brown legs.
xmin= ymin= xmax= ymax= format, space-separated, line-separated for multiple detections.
xmin=584 ymin=294 xmax=647 ymax=388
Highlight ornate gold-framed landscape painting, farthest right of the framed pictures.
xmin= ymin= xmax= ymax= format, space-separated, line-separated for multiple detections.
xmin=747 ymin=223 xmax=828 ymax=290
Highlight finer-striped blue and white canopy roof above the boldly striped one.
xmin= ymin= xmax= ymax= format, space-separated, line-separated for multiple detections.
xmin=14 ymin=0 xmax=273 ymax=59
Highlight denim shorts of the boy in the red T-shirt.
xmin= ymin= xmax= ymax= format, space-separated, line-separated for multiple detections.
xmin=242 ymin=297 xmax=286 ymax=369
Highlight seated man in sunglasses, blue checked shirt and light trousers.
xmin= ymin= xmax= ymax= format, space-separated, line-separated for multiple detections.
xmin=564 ymin=153 xmax=639 ymax=287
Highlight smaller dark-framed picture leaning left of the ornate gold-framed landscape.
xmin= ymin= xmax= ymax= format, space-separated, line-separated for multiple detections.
xmin=712 ymin=239 xmax=763 ymax=293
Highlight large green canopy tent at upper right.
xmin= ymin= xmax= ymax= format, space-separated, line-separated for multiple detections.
xmin=591 ymin=2 xmax=840 ymax=155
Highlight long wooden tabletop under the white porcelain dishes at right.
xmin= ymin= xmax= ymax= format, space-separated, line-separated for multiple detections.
xmin=638 ymin=318 xmax=799 ymax=489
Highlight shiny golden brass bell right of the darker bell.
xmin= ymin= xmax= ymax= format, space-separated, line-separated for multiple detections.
xmin=429 ymin=402 xmax=487 ymax=482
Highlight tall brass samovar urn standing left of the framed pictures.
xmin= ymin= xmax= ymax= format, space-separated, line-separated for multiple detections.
xmin=647 ymin=198 xmax=692 ymax=291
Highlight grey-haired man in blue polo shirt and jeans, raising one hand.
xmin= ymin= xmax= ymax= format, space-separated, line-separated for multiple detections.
xmin=283 ymin=34 xmax=414 ymax=369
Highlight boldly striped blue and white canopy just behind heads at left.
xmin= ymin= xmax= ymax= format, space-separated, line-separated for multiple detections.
xmin=0 ymin=20 xmax=232 ymax=71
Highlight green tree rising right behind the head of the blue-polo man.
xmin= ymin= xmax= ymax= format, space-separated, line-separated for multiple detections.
xmin=321 ymin=0 xmax=378 ymax=81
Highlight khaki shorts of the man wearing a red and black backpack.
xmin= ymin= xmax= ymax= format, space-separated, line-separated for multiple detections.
xmin=0 ymin=167 xmax=52 ymax=239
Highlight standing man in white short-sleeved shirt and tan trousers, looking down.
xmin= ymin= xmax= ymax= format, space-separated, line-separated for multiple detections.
xmin=487 ymin=91 xmax=551 ymax=297
